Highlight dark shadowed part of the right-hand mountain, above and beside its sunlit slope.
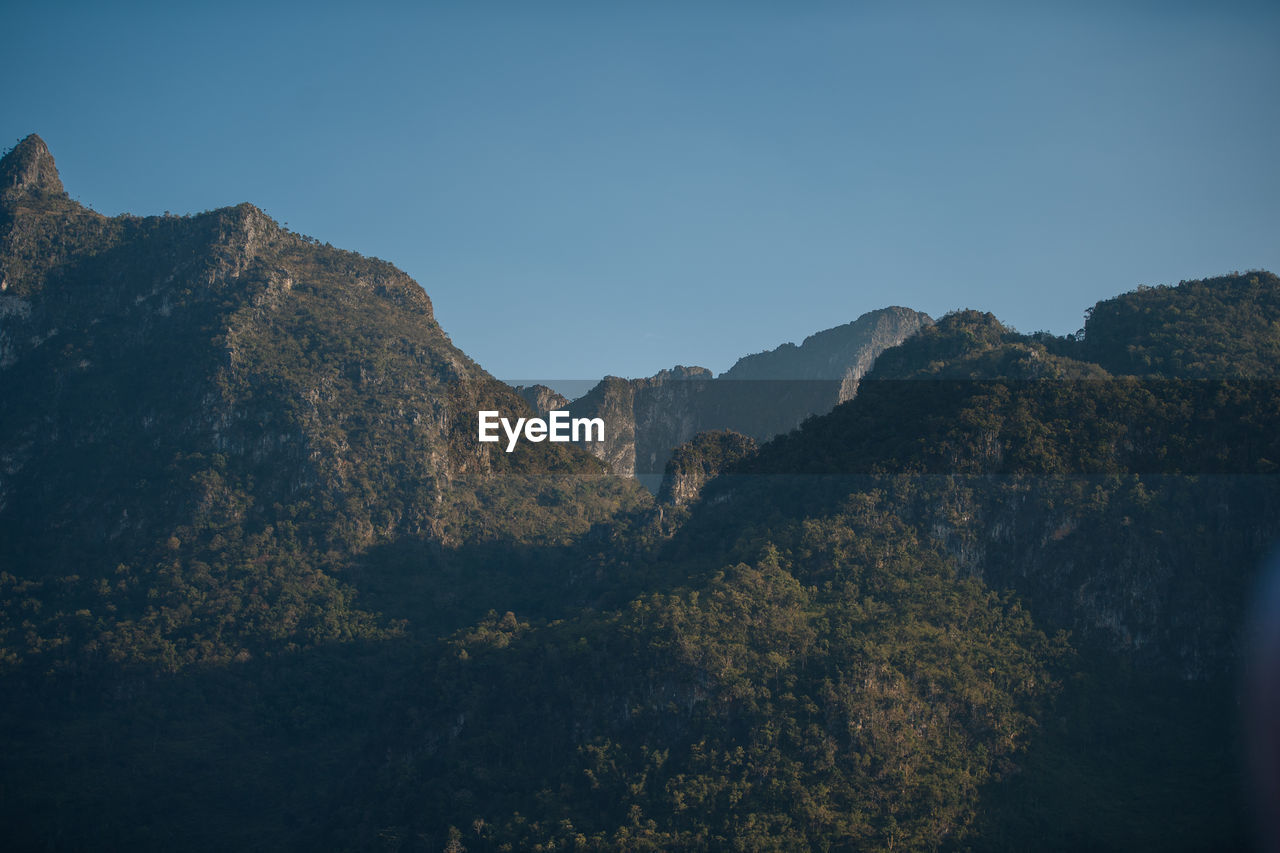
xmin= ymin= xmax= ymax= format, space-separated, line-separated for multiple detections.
xmin=672 ymin=273 xmax=1280 ymax=850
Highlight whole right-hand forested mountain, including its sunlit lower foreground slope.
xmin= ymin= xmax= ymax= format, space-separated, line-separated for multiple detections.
xmin=342 ymin=273 xmax=1280 ymax=850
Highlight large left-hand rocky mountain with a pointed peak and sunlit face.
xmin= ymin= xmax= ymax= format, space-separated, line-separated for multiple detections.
xmin=0 ymin=131 xmax=639 ymax=666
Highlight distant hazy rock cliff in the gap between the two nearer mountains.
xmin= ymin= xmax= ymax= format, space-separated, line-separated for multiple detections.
xmin=572 ymin=307 xmax=932 ymax=491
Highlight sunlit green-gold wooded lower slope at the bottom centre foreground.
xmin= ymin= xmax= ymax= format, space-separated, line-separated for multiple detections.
xmin=345 ymin=498 xmax=1061 ymax=850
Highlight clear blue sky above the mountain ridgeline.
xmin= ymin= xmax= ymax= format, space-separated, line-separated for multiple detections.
xmin=0 ymin=0 xmax=1280 ymax=378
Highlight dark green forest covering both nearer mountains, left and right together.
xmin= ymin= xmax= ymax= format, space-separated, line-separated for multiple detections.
xmin=0 ymin=137 xmax=1280 ymax=850
